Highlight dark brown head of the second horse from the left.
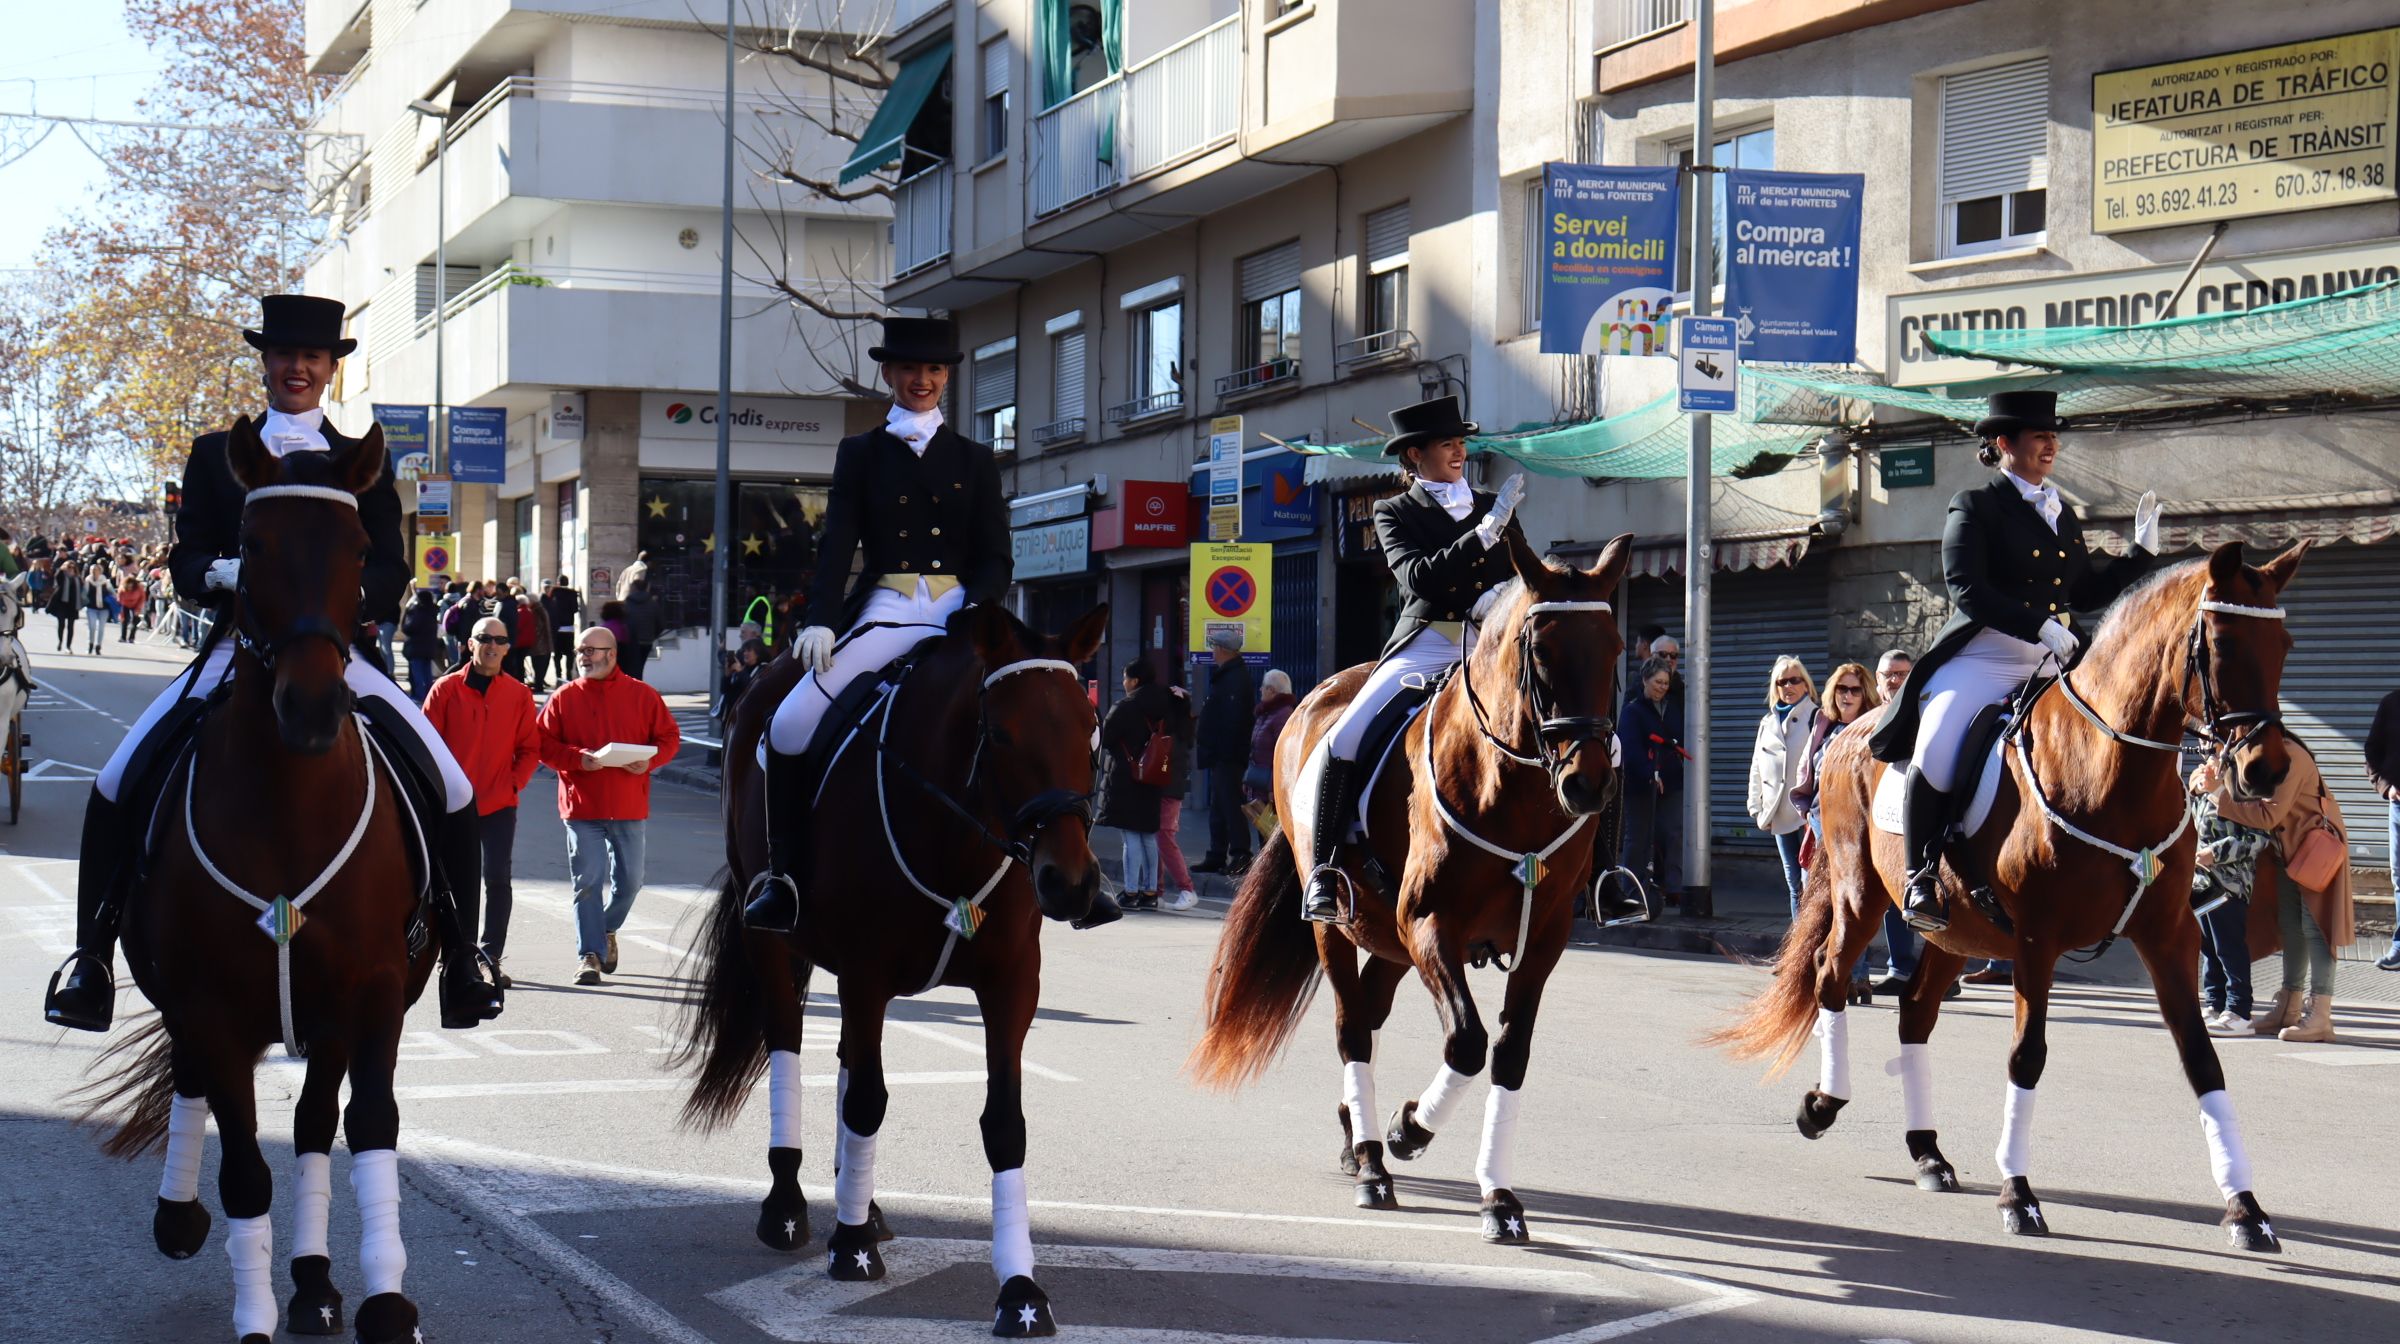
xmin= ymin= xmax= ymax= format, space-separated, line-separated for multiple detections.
xmin=967 ymin=602 xmax=1109 ymax=919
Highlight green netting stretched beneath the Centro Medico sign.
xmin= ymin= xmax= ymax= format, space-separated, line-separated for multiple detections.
xmin=1742 ymin=281 xmax=2400 ymax=425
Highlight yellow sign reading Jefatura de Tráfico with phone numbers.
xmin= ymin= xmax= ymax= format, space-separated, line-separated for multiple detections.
xmin=2093 ymin=29 xmax=2400 ymax=233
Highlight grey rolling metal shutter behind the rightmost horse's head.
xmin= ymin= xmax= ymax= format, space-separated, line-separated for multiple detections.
xmin=2251 ymin=542 xmax=2400 ymax=869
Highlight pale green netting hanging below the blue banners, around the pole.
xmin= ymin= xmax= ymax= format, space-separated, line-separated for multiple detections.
xmin=1294 ymin=394 xmax=1817 ymax=480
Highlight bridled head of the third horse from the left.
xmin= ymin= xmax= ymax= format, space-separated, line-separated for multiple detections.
xmin=1486 ymin=533 xmax=1634 ymax=816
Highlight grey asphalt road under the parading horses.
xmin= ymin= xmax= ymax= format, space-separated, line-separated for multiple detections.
xmin=0 ymin=636 xmax=2400 ymax=1344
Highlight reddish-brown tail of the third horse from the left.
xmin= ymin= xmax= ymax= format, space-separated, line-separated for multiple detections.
xmin=1183 ymin=830 xmax=1320 ymax=1087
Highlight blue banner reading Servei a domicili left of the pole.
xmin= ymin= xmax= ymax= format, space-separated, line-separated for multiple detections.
xmin=1541 ymin=163 xmax=1682 ymax=355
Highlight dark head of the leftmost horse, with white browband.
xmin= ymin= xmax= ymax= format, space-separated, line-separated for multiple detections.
xmin=226 ymin=418 xmax=384 ymax=756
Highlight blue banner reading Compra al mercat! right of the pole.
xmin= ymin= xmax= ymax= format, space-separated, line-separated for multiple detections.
xmin=1726 ymin=168 xmax=1867 ymax=365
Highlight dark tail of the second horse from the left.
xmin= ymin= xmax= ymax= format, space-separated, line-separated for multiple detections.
xmin=667 ymin=869 xmax=766 ymax=1133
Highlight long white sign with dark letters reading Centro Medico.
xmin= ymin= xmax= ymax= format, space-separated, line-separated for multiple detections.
xmin=1884 ymin=238 xmax=2400 ymax=386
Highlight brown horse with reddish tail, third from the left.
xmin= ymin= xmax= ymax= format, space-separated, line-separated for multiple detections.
xmin=1188 ymin=538 xmax=1632 ymax=1243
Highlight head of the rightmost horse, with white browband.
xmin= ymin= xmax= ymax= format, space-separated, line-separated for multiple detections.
xmin=2184 ymin=542 xmax=2309 ymax=799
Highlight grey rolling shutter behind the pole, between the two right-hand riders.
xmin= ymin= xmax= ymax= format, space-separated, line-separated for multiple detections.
xmin=1625 ymin=552 xmax=1834 ymax=850
